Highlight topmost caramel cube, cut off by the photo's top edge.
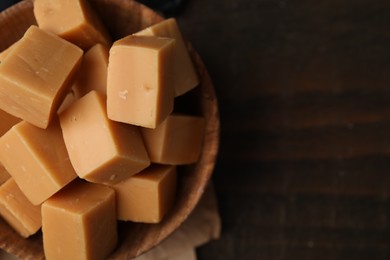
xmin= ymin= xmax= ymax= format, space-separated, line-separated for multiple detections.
xmin=34 ymin=0 xmax=111 ymax=50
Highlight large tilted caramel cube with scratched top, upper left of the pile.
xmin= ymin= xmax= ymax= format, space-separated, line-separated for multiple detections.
xmin=0 ymin=25 xmax=83 ymax=128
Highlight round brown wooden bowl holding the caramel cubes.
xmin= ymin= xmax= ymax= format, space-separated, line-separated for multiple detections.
xmin=0 ymin=0 xmax=219 ymax=259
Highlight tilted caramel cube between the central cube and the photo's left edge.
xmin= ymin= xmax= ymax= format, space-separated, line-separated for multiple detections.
xmin=0 ymin=120 xmax=77 ymax=205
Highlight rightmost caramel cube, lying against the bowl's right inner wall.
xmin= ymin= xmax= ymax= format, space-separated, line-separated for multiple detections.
xmin=141 ymin=114 xmax=205 ymax=165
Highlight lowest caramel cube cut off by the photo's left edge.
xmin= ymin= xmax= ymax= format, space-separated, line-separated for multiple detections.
xmin=0 ymin=178 xmax=42 ymax=238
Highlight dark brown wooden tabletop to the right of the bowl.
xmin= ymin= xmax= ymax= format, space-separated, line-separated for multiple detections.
xmin=177 ymin=0 xmax=390 ymax=260
